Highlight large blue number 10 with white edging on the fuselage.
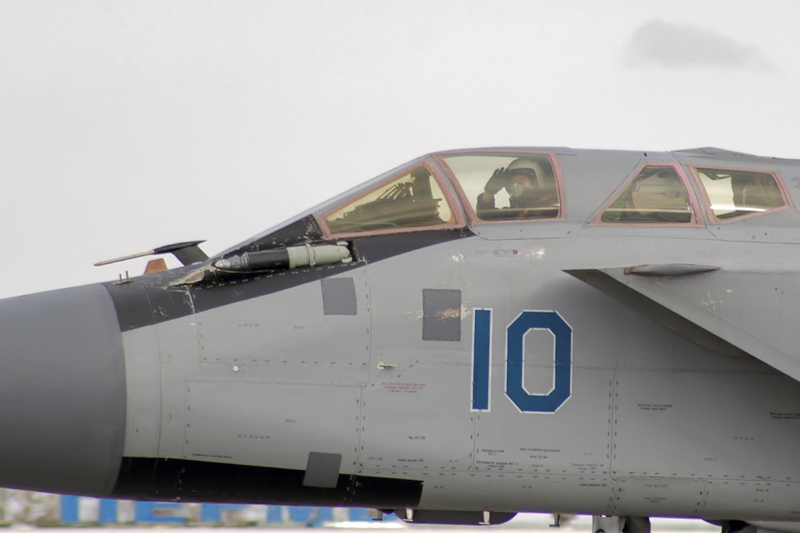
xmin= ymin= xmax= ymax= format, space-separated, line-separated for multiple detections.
xmin=472 ymin=309 xmax=572 ymax=413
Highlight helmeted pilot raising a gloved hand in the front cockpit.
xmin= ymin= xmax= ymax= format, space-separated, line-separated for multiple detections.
xmin=477 ymin=157 xmax=551 ymax=218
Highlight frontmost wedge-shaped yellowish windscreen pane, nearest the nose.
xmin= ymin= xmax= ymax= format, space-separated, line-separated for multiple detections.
xmin=323 ymin=166 xmax=454 ymax=234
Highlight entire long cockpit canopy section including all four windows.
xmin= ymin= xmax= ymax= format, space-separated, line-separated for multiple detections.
xmin=216 ymin=149 xmax=793 ymax=262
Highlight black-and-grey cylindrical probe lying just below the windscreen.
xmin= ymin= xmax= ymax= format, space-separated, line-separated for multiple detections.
xmin=212 ymin=242 xmax=353 ymax=272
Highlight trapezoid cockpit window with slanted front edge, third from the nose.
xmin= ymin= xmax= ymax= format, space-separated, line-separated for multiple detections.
xmin=600 ymin=166 xmax=692 ymax=224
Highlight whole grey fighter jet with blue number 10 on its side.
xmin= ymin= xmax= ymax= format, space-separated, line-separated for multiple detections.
xmin=0 ymin=148 xmax=800 ymax=533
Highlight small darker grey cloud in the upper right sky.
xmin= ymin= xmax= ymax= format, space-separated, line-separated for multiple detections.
xmin=625 ymin=20 xmax=774 ymax=70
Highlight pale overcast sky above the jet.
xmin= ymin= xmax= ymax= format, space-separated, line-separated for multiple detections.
xmin=0 ymin=0 xmax=800 ymax=297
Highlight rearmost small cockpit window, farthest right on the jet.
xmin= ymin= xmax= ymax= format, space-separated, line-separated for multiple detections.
xmin=694 ymin=167 xmax=787 ymax=220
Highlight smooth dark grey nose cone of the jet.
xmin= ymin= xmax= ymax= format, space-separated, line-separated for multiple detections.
xmin=0 ymin=285 xmax=125 ymax=496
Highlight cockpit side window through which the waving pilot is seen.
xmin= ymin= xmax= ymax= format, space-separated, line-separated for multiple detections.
xmin=442 ymin=154 xmax=561 ymax=221
